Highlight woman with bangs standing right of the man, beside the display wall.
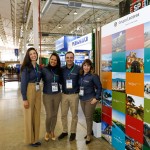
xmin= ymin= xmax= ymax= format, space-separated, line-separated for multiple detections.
xmin=79 ymin=59 xmax=102 ymax=144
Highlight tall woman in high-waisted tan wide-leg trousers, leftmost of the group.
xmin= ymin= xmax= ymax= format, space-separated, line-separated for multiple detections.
xmin=21 ymin=47 xmax=41 ymax=147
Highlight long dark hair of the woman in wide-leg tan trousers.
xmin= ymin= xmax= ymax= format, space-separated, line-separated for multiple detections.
xmin=21 ymin=47 xmax=38 ymax=72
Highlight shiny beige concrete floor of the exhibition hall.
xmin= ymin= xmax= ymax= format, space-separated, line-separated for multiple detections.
xmin=0 ymin=82 xmax=113 ymax=150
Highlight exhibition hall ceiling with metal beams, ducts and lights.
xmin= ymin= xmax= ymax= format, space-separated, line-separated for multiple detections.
xmin=0 ymin=0 xmax=122 ymax=51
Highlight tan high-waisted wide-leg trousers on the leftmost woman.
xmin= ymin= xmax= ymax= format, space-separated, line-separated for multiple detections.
xmin=24 ymin=83 xmax=41 ymax=144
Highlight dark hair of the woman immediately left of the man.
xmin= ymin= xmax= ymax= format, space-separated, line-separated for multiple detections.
xmin=47 ymin=52 xmax=61 ymax=73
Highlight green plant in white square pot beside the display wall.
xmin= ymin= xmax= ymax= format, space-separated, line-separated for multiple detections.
xmin=93 ymin=107 xmax=101 ymax=138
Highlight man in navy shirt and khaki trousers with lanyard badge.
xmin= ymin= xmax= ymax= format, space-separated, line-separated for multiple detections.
xmin=58 ymin=52 xmax=80 ymax=141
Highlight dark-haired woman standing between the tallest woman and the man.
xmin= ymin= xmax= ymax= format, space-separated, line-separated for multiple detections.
xmin=42 ymin=53 xmax=61 ymax=141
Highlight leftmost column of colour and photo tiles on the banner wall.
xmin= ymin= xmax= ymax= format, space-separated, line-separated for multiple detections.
xmin=101 ymin=36 xmax=112 ymax=144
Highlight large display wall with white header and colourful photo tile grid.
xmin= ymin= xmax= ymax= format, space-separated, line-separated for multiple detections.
xmin=101 ymin=6 xmax=150 ymax=150
